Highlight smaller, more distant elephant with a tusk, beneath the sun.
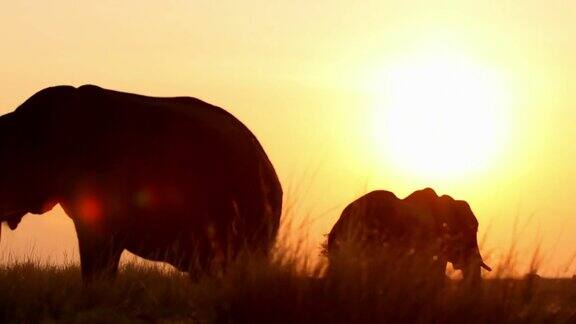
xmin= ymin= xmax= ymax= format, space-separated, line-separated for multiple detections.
xmin=326 ymin=188 xmax=491 ymax=281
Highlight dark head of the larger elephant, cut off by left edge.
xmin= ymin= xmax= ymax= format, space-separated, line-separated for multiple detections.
xmin=0 ymin=87 xmax=73 ymax=239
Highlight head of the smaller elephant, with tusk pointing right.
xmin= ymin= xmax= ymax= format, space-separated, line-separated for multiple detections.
xmin=404 ymin=188 xmax=492 ymax=280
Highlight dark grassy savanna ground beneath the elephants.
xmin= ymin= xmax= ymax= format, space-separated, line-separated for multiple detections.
xmin=0 ymin=221 xmax=576 ymax=323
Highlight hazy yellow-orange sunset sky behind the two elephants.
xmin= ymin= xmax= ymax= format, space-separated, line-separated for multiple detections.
xmin=0 ymin=0 xmax=576 ymax=274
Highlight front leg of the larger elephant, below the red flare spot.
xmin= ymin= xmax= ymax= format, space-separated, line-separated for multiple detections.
xmin=76 ymin=226 xmax=124 ymax=283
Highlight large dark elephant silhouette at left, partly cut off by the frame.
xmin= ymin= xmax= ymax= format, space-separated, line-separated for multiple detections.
xmin=0 ymin=85 xmax=282 ymax=281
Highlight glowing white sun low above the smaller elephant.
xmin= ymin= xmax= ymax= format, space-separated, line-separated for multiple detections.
xmin=374 ymin=54 xmax=509 ymax=178
